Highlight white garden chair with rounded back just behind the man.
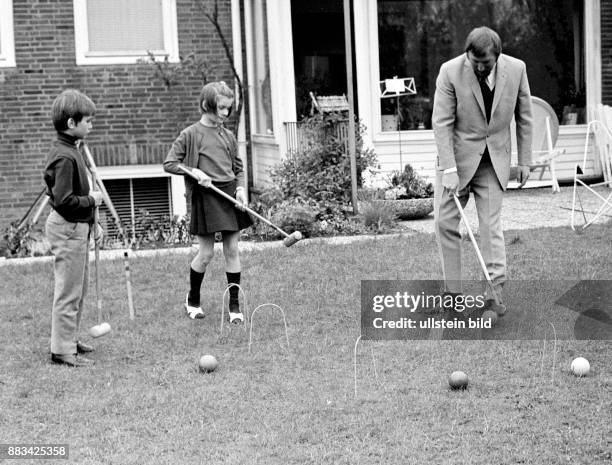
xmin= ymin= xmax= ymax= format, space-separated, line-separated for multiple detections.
xmin=508 ymin=97 xmax=565 ymax=192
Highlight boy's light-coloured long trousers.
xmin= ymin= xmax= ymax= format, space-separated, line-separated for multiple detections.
xmin=45 ymin=210 xmax=90 ymax=354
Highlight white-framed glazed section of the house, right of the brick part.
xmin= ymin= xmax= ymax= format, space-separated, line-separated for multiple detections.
xmin=247 ymin=0 xmax=612 ymax=185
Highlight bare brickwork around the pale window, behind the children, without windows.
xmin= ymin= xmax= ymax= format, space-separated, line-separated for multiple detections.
xmin=0 ymin=0 xmax=233 ymax=231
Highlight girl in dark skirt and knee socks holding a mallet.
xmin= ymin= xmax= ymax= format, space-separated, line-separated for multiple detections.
xmin=164 ymin=81 xmax=253 ymax=323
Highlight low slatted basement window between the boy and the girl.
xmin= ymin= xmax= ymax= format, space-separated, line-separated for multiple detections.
xmin=100 ymin=176 xmax=172 ymax=240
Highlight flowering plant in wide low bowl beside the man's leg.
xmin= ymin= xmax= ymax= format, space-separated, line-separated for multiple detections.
xmin=376 ymin=164 xmax=434 ymax=220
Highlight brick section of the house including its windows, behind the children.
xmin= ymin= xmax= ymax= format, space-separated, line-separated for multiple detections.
xmin=0 ymin=0 xmax=239 ymax=230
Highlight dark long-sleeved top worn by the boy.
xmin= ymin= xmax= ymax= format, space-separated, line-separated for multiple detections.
xmin=44 ymin=133 xmax=95 ymax=223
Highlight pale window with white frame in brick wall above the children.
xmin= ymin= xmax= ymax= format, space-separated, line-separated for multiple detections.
xmin=74 ymin=0 xmax=179 ymax=65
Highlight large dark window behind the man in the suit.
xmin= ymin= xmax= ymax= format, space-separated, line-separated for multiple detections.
xmin=378 ymin=0 xmax=586 ymax=131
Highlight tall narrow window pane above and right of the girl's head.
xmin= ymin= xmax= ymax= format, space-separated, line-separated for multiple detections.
xmin=250 ymin=0 xmax=274 ymax=135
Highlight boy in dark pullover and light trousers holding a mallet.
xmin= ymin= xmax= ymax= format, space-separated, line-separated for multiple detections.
xmin=43 ymin=89 xmax=102 ymax=367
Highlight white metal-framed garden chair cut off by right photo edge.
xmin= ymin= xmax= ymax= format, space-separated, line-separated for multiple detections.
xmin=570 ymin=104 xmax=612 ymax=233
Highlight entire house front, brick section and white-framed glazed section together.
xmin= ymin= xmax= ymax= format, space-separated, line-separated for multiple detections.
xmin=0 ymin=0 xmax=612 ymax=232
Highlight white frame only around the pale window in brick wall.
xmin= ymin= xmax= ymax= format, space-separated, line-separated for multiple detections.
xmin=73 ymin=0 xmax=179 ymax=65
